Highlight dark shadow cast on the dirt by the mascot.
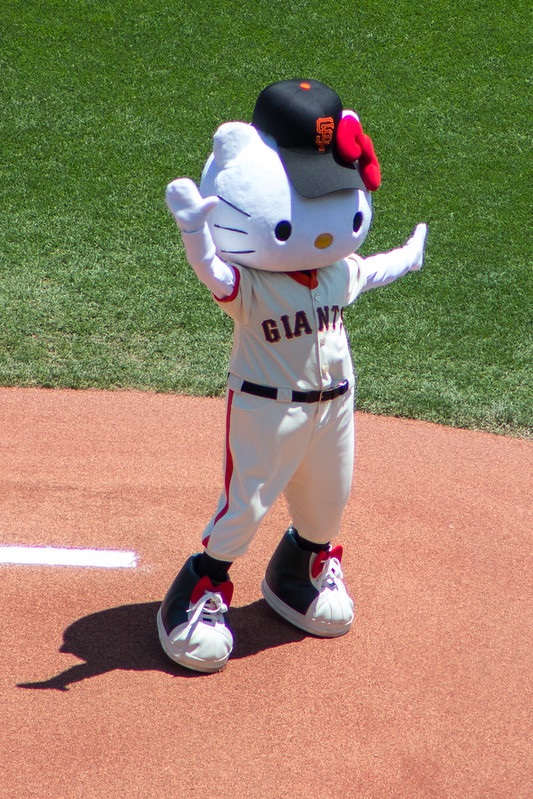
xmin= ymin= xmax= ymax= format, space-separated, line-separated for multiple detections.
xmin=18 ymin=599 xmax=306 ymax=691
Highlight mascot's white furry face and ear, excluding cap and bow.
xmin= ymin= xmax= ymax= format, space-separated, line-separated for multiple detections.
xmin=200 ymin=122 xmax=372 ymax=272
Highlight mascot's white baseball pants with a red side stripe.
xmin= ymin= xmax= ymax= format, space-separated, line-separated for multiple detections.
xmin=202 ymin=389 xmax=354 ymax=561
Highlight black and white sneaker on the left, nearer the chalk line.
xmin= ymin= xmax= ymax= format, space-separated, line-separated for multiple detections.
xmin=157 ymin=555 xmax=233 ymax=673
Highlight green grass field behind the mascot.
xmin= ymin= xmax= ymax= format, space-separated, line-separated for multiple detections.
xmin=0 ymin=0 xmax=533 ymax=435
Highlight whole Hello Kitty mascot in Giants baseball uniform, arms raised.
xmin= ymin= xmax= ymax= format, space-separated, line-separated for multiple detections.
xmin=157 ymin=80 xmax=427 ymax=672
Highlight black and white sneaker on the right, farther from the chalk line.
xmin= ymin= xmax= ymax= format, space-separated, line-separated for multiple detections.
xmin=261 ymin=528 xmax=354 ymax=638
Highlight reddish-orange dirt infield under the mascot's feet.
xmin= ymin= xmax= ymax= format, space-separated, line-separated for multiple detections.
xmin=0 ymin=389 xmax=533 ymax=799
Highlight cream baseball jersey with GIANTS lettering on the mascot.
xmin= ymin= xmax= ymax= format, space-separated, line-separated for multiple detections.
xmin=218 ymin=256 xmax=366 ymax=394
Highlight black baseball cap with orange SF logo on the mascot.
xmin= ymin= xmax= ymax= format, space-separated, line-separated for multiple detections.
xmin=252 ymin=80 xmax=365 ymax=198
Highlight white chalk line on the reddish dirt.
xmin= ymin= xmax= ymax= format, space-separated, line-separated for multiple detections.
xmin=0 ymin=546 xmax=139 ymax=569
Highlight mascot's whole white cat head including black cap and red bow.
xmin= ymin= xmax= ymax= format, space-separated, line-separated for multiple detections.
xmin=200 ymin=80 xmax=380 ymax=272
